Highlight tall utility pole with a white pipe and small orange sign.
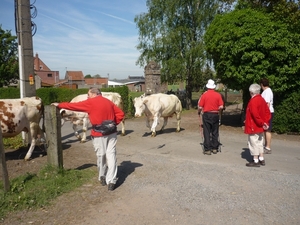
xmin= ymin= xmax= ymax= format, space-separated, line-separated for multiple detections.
xmin=15 ymin=0 xmax=36 ymax=98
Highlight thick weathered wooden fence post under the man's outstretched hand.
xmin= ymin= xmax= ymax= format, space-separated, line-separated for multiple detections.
xmin=45 ymin=105 xmax=63 ymax=168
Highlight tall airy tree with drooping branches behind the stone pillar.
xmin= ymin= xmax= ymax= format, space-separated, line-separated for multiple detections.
xmin=135 ymin=0 xmax=219 ymax=109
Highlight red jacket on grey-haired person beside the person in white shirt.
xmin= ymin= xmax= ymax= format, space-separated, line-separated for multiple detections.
xmin=244 ymin=94 xmax=271 ymax=134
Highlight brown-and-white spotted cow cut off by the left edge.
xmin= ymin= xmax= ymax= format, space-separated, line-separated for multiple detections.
xmin=0 ymin=97 xmax=45 ymax=160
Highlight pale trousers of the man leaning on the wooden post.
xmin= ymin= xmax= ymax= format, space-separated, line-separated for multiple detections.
xmin=93 ymin=133 xmax=118 ymax=184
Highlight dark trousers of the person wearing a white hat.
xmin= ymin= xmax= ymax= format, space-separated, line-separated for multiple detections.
xmin=202 ymin=113 xmax=220 ymax=151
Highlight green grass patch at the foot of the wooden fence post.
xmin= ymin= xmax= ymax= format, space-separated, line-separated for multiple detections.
xmin=0 ymin=165 xmax=96 ymax=221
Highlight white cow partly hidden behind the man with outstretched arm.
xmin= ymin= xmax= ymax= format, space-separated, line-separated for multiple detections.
xmin=60 ymin=92 xmax=125 ymax=143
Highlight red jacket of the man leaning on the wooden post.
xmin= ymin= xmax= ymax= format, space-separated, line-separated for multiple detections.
xmin=58 ymin=95 xmax=124 ymax=137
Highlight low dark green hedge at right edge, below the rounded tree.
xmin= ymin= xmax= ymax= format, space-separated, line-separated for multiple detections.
xmin=272 ymin=91 xmax=300 ymax=134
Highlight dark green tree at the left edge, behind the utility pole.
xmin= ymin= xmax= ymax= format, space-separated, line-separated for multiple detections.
xmin=0 ymin=25 xmax=19 ymax=87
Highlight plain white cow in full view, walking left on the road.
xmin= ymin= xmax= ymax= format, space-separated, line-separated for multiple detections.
xmin=133 ymin=94 xmax=182 ymax=137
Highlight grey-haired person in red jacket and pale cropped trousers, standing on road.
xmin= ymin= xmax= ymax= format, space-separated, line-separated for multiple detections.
xmin=244 ymin=84 xmax=271 ymax=167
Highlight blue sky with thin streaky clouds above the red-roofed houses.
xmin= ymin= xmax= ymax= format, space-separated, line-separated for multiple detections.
xmin=0 ymin=0 xmax=147 ymax=79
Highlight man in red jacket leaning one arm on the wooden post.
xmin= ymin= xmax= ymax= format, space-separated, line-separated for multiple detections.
xmin=51 ymin=87 xmax=124 ymax=191
